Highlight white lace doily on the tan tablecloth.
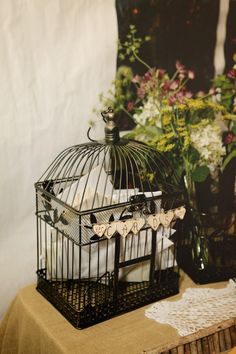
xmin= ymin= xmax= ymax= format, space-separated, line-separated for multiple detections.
xmin=145 ymin=280 xmax=236 ymax=336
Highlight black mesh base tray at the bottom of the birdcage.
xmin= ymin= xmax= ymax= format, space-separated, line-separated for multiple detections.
xmin=37 ymin=270 xmax=179 ymax=329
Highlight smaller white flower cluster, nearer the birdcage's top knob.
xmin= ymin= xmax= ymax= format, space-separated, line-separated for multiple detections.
xmin=134 ymin=97 xmax=161 ymax=128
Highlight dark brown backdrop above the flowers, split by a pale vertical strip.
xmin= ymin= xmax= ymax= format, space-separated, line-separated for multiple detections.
xmin=116 ymin=0 xmax=236 ymax=92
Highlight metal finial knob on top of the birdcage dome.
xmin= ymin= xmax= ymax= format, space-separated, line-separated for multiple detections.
xmin=102 ymin=107 xmax=120 ymax=143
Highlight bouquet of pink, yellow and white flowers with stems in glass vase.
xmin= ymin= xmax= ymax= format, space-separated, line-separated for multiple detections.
xmin=96 ymin=25 xmax=236 ymax=280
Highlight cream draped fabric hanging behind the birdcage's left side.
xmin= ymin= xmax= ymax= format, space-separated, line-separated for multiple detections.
xmin=0 ymin=0 xmax=117 ymax=318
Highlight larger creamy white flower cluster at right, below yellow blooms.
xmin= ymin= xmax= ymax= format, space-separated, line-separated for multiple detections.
xmin=190 ymin=122 xmax=226 ymax=174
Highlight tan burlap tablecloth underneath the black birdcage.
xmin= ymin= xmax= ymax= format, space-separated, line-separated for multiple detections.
xmin=0 ymin=273 xmax=234 ymax=354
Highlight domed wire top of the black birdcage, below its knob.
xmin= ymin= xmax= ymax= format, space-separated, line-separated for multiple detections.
xmin=36 ymin=112 xmax=178 ymax=207
